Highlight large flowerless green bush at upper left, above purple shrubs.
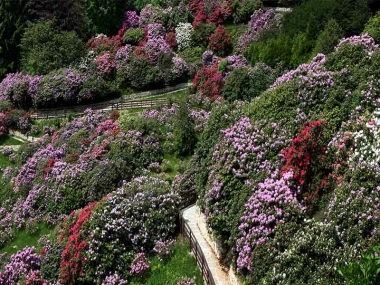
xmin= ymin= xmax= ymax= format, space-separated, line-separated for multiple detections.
xmin=20 ymin=20 xmax=85 ymax=75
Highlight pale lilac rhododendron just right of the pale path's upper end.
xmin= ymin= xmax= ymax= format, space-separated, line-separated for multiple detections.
xmin=200 ymin=117 xmax=291 ymax=239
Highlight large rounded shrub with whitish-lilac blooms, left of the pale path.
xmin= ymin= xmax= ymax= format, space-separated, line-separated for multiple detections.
xmin=80 ymin=177 xmax=178 ymax=280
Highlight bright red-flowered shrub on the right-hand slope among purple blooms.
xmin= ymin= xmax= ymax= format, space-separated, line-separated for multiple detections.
xmin=281 ymin=121 xmax=328 ymax=201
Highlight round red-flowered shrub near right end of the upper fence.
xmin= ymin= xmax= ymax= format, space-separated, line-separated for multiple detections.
xmin=193 ymin=65 xmax=225 ymax=99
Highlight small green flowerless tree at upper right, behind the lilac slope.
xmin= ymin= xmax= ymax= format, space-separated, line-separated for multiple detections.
xmin=314 ymin=19 xmax=344 ymax=54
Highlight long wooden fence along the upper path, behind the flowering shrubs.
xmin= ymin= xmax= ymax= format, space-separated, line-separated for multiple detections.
xmin=31 ymin=98 xmax=175 ymax=120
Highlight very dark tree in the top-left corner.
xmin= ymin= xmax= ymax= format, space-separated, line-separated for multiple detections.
xmin=0 ymin=0 xmax=28 ymax=78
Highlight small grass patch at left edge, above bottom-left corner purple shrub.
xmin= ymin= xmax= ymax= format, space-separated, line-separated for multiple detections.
xmin=0 ymin=223 xmax=53 ymax=254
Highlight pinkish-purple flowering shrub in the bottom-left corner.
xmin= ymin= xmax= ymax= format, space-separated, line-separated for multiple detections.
xmin=0 ymin=246 xmax=41 ymax=285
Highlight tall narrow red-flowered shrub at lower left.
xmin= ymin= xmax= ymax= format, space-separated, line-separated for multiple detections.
xmin=59 ymin=203 xmax=97 ymax=284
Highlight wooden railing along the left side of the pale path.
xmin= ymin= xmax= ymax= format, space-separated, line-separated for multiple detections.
xmin=179 ymin=209 xmax=216 ymax=285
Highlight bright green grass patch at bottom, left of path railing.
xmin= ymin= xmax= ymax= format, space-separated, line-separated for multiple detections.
xmin=129 ymin=238 xmax=204 ymax=285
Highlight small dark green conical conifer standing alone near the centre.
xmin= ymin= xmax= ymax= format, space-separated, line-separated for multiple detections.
xmin=173 ymin=104 xmax=197 ymax=156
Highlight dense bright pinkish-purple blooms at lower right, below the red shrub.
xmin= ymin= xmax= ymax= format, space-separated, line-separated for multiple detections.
xmin=236 ymin=171 xmax=304 ymax=271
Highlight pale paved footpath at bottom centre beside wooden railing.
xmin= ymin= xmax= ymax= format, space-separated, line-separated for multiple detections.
xmin=182 ymin=205 xmax=230 ymax=285
